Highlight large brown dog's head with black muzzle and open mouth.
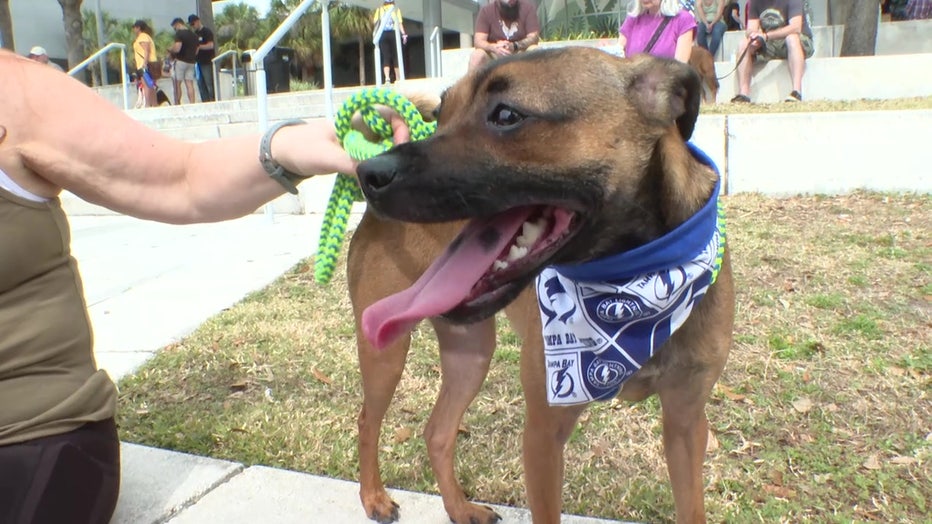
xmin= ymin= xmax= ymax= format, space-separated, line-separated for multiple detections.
xmin=358 ymin=47 xmax=709 ymax=338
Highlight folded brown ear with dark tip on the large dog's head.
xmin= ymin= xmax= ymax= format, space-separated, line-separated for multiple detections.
xmin=627 ymin=56 xmax=702 ymax=140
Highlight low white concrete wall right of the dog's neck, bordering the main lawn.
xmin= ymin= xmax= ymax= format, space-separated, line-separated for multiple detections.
xmin=693 ymin=110 xmax=932 ymax=196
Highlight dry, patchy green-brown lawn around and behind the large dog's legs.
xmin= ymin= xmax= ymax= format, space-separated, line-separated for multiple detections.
xmin=118 ymin=193 xmax=932 ymax=523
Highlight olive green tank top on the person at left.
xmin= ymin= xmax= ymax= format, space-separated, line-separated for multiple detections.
xmin=0 ymin=188 xmax=117 ymax=445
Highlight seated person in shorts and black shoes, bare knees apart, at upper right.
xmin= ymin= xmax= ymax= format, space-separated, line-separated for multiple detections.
xmin=731 ymin=0 xmax=815 ymax=104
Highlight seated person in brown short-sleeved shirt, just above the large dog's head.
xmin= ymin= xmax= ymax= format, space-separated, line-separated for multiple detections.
xmin=469 ymin=0 xmax=540 ymax=71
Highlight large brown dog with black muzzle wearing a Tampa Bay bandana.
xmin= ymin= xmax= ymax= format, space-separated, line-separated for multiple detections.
xmin=348 ymin=48 xmax=734 ymax=523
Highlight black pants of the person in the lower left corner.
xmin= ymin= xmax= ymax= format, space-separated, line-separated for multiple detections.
xmin=0 ymin=418 xmax=120 ymax=524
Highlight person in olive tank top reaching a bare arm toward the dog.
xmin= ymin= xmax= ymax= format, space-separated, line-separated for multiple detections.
xmin=0 ymin=50 xmax=410 ymax=524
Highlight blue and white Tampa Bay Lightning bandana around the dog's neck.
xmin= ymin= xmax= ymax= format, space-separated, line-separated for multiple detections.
xmin=537 ymin=144 xmax=725 ymax=405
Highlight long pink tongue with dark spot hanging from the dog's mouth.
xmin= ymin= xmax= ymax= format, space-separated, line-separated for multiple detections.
xmin=362 ymin=208 xmax=532 ymax=349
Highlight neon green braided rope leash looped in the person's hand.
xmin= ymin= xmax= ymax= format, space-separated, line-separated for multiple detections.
xmin=314 ymin=88 xmax=437 ymax=284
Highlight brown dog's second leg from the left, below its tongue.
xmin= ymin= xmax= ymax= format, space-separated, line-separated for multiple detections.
xmin=424 ymin=318 xmax=501 ymax=524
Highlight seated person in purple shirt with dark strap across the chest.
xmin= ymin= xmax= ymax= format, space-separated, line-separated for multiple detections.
xmin=618 ymin=0 xmax=696 ymax=63
